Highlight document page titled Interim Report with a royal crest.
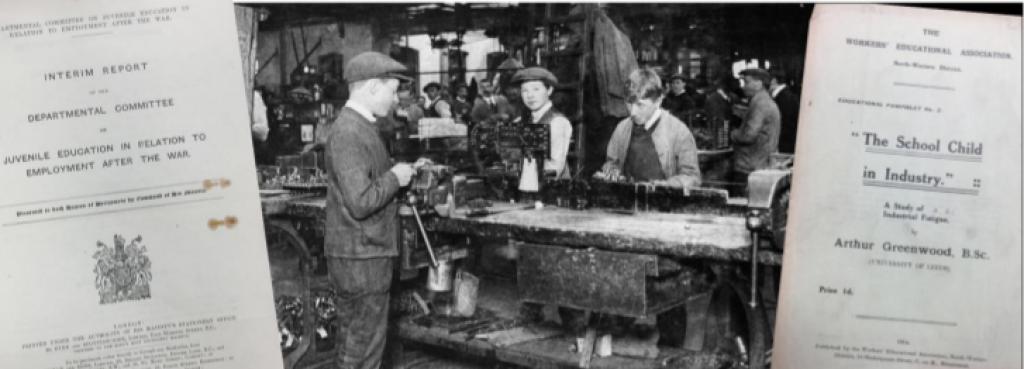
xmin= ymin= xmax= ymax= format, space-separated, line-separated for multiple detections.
xmin=0 ymin=0 xmax=282 ymax=369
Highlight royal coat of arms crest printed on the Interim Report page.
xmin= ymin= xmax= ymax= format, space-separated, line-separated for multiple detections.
xmin=92 ymin=235 xmax=153 ymax=304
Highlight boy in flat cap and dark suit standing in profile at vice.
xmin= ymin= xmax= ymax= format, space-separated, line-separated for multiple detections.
xmin=324 ymin=51 xmax=414 ymax=369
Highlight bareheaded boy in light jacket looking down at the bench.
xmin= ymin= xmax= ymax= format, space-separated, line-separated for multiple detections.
xmin=594 ymin=69 xmax=700 ymax=188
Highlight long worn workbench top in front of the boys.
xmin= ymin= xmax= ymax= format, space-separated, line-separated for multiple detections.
xmin=283 ymin=197 xmax=782 ymax=265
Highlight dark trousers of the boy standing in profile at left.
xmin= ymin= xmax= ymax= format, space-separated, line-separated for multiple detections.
xmin=328 ymin=257 xmax=394 ymax=369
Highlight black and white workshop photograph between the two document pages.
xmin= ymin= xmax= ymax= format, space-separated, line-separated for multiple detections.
xmin=247 ymin=3 xmax=813 ymax=368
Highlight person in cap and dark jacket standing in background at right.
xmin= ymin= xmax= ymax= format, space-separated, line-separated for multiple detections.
xmin=729 ymin=69 xmax=780 ymax=191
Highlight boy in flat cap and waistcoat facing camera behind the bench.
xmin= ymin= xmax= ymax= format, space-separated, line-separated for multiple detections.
xmin=512 ymin=67 xmax=572 ymax=178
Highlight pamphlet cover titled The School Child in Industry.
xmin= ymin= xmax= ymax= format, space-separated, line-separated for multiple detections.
xmin=772 ymin=4 xmax=1021 ymax=369
